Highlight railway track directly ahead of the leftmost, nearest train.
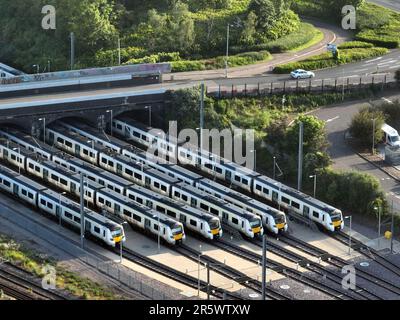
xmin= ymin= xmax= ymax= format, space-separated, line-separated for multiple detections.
xmin=123 ymin=248 xmax=243 ymax=300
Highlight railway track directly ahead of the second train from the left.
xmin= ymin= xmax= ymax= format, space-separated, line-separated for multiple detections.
xmin=174 ymin=245 xmax=290 ymax=300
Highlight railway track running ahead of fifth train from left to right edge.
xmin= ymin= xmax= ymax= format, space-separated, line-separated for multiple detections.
xmin=279 ymin=234 xmax=400 ymax=295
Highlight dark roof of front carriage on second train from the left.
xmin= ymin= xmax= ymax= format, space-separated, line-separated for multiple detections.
xmin=98 ymin=190 xmax=182 ymax=228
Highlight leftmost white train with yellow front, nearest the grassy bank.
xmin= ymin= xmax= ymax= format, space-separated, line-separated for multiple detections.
xmin=0 ymin=166 xmax=125 ymax=247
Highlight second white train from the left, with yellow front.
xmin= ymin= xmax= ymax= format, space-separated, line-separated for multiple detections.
xmin=0 ymin=138 xmax=186 ymax=244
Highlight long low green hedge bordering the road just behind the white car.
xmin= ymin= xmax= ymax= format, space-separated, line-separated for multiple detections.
xmin=274 ymin=48 xmax=389 ymax=73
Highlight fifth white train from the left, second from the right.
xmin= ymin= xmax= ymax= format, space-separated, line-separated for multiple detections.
xmin=59 ymin=121 xmax=288 ymax=234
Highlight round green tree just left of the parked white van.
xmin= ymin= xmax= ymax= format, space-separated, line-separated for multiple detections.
xmin=350 ymin=107 xmax=386 ymax=146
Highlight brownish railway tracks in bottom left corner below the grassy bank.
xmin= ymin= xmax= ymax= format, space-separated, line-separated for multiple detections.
xmin=0 ymin=263 xmax=67 ymax=300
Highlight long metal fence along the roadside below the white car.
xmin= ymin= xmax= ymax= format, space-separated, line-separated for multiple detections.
xmin=207 ymin=73 xmax=397 ymax=98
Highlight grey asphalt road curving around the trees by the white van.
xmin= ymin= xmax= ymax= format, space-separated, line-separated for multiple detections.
xmin=312 ymin=95 xmax=400 ymax=212
